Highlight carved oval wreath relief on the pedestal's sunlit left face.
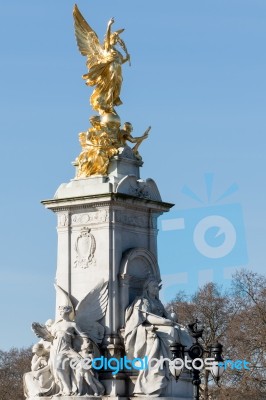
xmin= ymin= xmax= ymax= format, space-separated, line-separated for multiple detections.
xmin=74 ymin=227 xmax=96 ymax=269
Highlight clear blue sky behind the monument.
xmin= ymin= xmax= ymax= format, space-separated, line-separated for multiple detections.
xmin=0 ymin=0 xmax=266 ymax=349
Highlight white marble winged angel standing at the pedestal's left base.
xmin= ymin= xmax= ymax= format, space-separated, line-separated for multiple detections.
xmin=32 ymin=283 xmax=108 ymax=396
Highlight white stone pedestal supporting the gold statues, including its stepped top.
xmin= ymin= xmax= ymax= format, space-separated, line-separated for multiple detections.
xmin=37 ymin=147 xmax=192 ymax=400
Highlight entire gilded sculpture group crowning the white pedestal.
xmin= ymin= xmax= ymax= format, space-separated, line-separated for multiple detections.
xmin=73 ymin=5 xmax=150 ymax=178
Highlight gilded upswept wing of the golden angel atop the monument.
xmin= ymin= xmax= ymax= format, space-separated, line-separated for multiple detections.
xmin=73 ymin=4 xmax=105 ymax=69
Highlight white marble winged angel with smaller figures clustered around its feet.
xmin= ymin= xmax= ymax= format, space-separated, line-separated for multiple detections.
xmin=29 ymin=282 xmax=108 ymax=396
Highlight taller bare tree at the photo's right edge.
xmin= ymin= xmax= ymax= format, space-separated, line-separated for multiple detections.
xmin=218 ymin=269 xmax=266 ymax=400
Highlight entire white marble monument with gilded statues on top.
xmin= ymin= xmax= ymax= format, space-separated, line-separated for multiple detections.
xmin=24 ymin=5 xmax=192 ymax=400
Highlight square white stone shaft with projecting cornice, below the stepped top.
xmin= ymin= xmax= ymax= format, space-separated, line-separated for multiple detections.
xmin=42 ymin=176 xmax=172 ymax=337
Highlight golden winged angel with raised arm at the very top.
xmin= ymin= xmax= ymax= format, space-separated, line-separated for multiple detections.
xmin=73 ymin=5 xmax=130 ymax=115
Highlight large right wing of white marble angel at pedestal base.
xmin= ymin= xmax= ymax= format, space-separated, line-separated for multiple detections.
xmin=76 ymin=282 xmax=108 ymax=343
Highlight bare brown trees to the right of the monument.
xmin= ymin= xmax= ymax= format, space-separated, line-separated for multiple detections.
xmin=167 ymin=270 xmax=266 ymax=400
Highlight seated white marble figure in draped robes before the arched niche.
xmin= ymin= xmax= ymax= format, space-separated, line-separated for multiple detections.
xmin=124 ymin=277 xmax=193 ymax=396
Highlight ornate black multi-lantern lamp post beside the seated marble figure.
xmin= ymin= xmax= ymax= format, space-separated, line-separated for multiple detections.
xmin=170 ymin=320 xmax=224 ymax=400
